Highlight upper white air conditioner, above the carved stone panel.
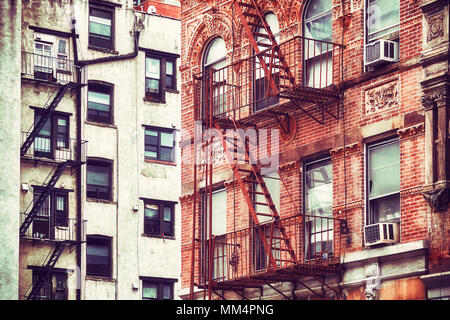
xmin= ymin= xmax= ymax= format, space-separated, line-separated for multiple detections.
xmin=364 ymin=40 xmax=399 ymax=67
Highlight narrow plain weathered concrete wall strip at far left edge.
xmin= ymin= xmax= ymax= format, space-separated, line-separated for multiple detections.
xmin=0 ymin=0 xmax=22 ymax=300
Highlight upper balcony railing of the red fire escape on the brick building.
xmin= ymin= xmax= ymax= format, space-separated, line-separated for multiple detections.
xmin=194 ymin=36 xmax=343 ymax=124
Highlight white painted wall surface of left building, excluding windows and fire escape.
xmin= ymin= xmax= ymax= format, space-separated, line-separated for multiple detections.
xmin=5 ymin=0 xmax=181 ymax=300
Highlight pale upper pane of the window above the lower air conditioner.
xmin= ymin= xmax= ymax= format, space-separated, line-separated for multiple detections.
xmin=368 ymin=142 xmax=400 ymax=199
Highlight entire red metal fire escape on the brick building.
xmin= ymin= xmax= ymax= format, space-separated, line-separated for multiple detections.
xmin=191 ymin=0 xmax=342 ymax=299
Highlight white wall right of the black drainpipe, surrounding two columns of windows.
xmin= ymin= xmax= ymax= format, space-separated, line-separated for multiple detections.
xmin=75 ymin=1 xmax=181 ymax=300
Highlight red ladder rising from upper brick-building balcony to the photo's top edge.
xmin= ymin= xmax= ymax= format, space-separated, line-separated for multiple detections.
xmin=234 ymin=0 xmax=295 ymax=96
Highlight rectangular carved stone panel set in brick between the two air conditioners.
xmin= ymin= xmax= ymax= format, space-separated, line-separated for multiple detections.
xmin=365 ymin=81 xmax=399 ymax=115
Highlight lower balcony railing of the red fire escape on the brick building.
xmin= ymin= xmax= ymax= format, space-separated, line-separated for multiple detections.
xmin=195 ymin=215 xmax=344 ymax=287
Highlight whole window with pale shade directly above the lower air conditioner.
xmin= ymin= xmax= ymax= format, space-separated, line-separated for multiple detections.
xmin=366 ymin=140 xmax=400 ymax=225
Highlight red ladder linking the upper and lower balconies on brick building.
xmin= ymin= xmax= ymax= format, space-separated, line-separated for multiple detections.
xmin=214 ymin=119 xmax=298 ymax=270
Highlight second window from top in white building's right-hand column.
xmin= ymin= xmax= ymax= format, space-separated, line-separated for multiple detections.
xmin=145 ymin=128 xmax=175 ymax=162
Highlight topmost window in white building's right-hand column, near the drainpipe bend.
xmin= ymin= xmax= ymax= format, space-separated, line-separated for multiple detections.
xmin=145 ymin=53 xmax=177 ymax=102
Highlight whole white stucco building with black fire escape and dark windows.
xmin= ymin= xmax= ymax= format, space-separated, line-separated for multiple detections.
xmin=0 ymin=0 xmax=181 ymax=300
